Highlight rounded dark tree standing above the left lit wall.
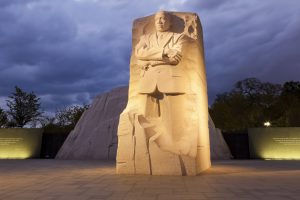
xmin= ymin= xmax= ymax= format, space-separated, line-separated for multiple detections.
xmin=7 ymin=86 xmax=41 ymax=127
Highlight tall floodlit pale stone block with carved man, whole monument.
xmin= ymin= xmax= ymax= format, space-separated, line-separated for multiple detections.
xmin=117 ymin=11 xmax=210 ymax=175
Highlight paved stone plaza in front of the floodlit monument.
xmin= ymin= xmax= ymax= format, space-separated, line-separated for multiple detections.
xmin=0 ymin=160 xmax=300 ymax=200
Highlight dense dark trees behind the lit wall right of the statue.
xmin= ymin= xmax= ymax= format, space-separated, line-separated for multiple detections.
xmin=209 ymin=78 xmax=300 ymax=132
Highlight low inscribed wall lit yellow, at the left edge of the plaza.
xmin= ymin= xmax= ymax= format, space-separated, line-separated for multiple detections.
xmin=0 ymin=128 xmax=43 ymax=159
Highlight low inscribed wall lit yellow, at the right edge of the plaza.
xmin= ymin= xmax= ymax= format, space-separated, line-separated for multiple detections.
xmin=248 ymin=127 xmax=300 ymax=160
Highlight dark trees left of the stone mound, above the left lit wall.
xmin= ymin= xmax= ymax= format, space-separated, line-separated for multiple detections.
xmin=0 ymin=86 xmax=89 ymax=130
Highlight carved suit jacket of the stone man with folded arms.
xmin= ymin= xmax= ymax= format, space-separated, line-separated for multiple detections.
xmin=135 ymin=32 xmax=187 ymax=94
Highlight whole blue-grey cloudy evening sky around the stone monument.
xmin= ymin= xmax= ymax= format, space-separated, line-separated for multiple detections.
xmin=0 ymin=0 xmax=300 ymax=111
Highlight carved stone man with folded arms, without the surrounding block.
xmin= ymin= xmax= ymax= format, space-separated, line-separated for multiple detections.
xmin=135 ymin=11 xmax=196 ymax=156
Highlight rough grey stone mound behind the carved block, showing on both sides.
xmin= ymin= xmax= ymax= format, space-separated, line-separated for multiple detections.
xmin=56 ymin=86 xmax=231 ymax=160
